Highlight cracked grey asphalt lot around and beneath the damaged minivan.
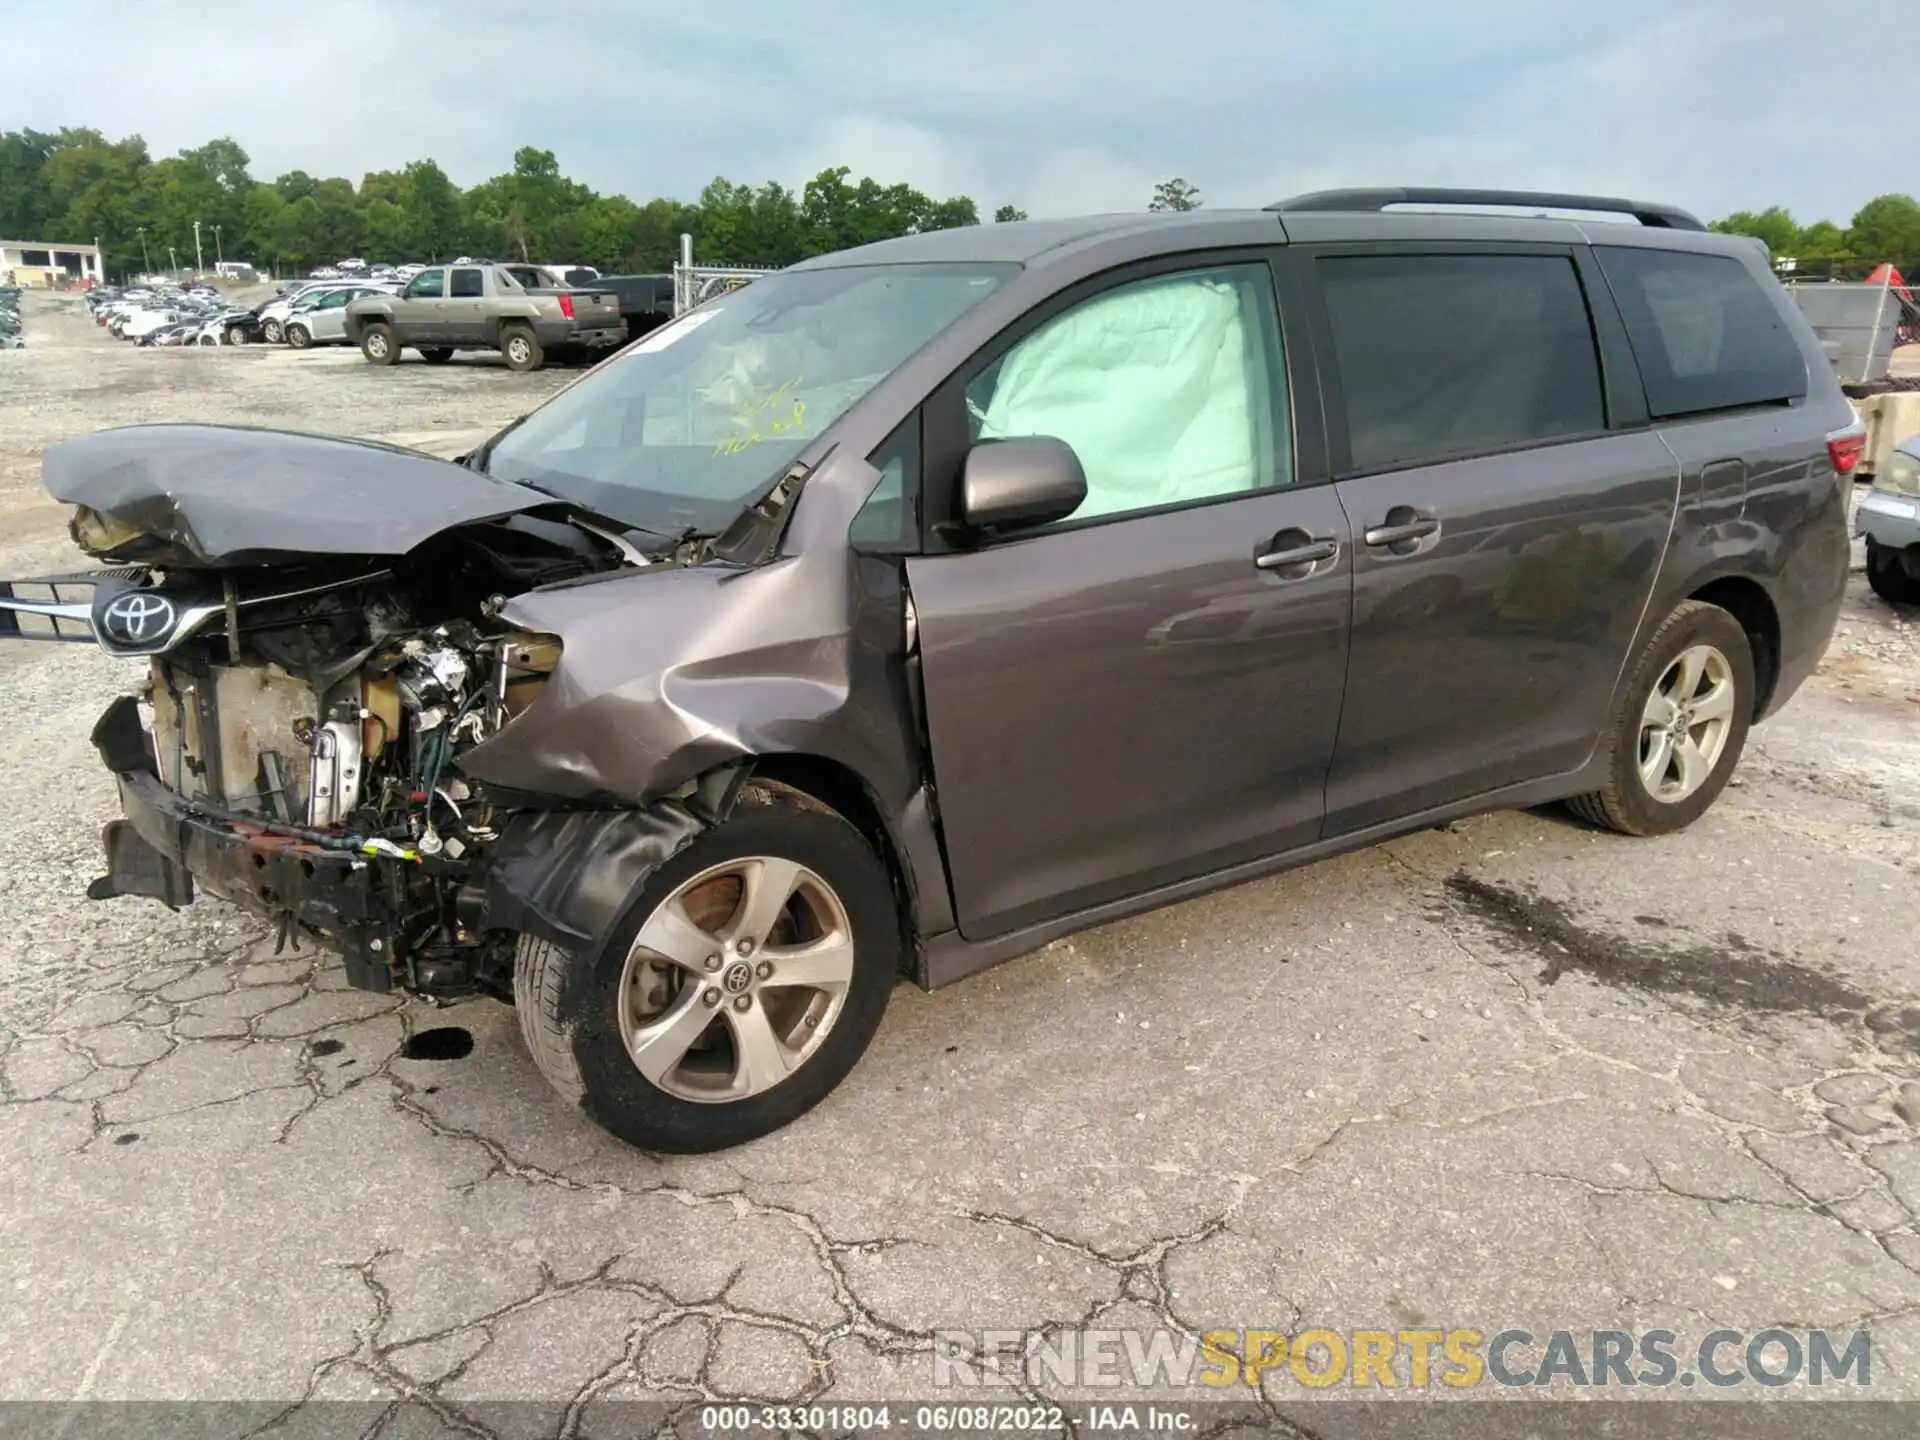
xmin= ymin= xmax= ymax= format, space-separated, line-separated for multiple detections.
xmin=0 ymin=289 xmax=1920 ymax=1434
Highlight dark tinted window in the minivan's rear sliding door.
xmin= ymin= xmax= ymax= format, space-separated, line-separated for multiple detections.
xmin=1315 ymin=255 xmax=1607 ymax=480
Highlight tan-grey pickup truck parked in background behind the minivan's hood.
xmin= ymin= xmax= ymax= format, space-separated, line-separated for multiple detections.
xmin=346 ymin=265 xmax=626 ymax=371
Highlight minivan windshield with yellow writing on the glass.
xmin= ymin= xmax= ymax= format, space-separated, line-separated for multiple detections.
xmin=482 ymin=265 xmax=1018 ymax=536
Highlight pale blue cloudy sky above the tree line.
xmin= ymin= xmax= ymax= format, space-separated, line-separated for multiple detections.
xmin=0 ymin=0 xmax=1920 ymax=223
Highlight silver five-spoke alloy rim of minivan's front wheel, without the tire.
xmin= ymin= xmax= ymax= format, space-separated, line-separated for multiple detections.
xmin=618 ymin=854 xmax=854 ymax=1104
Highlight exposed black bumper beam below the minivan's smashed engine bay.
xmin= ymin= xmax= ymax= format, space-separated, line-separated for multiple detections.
xmin=86 ymin=697 xmax=424 ymax=991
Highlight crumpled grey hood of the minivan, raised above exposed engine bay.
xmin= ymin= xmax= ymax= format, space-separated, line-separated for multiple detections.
xmin=40 ymin=424 xmax=555 ymax=568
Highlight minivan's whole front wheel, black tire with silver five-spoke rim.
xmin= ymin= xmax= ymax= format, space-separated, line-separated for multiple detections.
xmin=513 ymin=804 xmax=900 ymax=1154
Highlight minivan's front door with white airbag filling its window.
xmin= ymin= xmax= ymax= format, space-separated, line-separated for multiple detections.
xmin=906 ymin=253 xmax=1352 ymax=939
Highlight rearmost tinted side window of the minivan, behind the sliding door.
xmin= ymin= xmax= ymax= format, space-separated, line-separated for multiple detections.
xmin=1594 ymin=246 xmax=1807 ymax=420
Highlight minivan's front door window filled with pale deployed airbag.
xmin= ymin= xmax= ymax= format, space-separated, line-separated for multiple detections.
xmin=966 ymin=265 xmax=1292 ymax=520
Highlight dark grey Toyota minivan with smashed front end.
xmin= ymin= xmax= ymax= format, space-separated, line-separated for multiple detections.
xmin=0 ymin=192 xmax=1860 ymax=1150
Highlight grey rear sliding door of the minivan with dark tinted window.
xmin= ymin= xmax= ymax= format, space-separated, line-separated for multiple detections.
xmin=1304 ymin=244 xmax=1678 ymax=835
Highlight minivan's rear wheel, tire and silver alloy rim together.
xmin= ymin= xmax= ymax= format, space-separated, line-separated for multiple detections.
xmin=1567 ymin=601 xmax=1757 ymax=835
